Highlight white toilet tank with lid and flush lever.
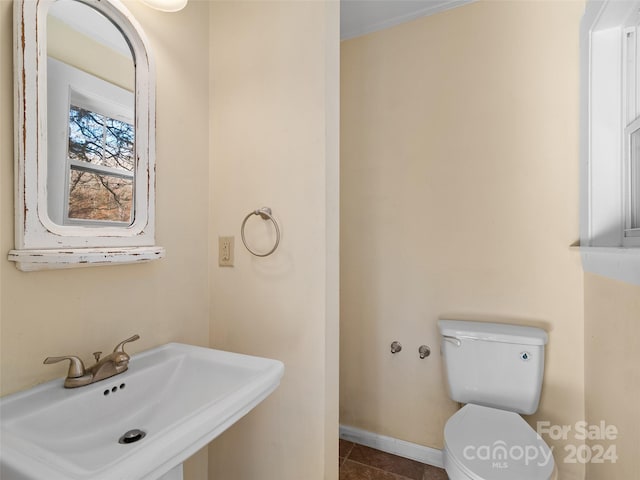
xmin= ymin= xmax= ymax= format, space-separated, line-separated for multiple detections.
xmin=438 ymin=320 xmax=548 ymax=414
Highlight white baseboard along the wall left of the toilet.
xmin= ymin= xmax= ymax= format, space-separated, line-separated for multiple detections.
xmin=340 ymin=425 xmax=444 ymax=468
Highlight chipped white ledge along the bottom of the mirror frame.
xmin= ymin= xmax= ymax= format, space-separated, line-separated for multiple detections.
xmin=8 ymin=247 xmax=165 ymax=272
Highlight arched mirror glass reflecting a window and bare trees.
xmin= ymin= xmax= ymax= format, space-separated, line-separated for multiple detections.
xmin=47 ymin=0 xmax=135 ymax=227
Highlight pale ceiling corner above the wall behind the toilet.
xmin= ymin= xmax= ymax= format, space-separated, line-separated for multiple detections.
xmin=340 ymin=0 xmax=473 ymax=40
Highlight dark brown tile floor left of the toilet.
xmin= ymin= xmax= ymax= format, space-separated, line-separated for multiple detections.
xmin=338 ymin=440 xmax=449 ymax=480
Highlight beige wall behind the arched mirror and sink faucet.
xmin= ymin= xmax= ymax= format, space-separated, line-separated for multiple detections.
xmin=0 ymin=1 xmax=209 ymax=479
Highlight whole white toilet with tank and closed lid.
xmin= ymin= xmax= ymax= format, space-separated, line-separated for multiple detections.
xmin=438 ymin=320 xmax=557 ymax=480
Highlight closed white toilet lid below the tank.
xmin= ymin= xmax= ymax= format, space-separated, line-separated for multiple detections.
xmin=444 ymin=404 xmax=555 ymax=480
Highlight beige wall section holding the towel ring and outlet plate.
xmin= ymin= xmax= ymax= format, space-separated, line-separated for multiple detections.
xmin=209 ymin=2 xmax=339 ymax=480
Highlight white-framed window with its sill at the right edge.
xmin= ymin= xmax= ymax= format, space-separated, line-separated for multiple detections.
xmin=580 ymin=0 xmax=640 ymax=285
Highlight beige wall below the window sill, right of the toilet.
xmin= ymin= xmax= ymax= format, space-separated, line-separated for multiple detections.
xmin=585 ymin=274 xmax=640 ymax=480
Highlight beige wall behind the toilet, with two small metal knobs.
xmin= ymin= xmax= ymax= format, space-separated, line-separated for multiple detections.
xmin=340 ymin=1 xmax=584 ymax=480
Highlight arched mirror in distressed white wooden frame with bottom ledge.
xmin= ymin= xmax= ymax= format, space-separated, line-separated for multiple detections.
xmin=9 ymin=0 xmax=164 ymax=271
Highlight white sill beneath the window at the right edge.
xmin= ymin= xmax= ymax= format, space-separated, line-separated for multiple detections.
xmin=575 ymin=247 xmax=640 ymax=285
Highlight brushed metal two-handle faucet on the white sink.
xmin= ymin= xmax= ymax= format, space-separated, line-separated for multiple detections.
xmin=43 ymin=334 xmax=140 ymax=388
